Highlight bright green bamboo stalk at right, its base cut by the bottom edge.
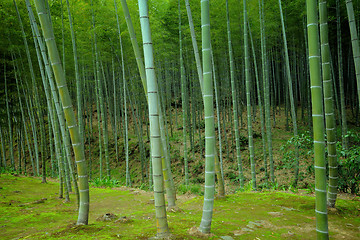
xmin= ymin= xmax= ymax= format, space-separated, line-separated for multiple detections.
xmin=306 ymin=0 xmax=329 ymax=239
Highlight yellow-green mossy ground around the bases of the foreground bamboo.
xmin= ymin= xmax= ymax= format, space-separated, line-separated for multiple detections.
xmin=0 ymin=174 xmax=360 ymax=240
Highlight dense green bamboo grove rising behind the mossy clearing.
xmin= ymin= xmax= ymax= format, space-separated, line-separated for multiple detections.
xmin=0 ymin=0 xmax=360 ymax=237
